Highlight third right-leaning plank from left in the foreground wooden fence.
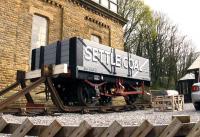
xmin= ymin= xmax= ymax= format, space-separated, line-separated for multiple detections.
xmin=39 ymin=120 xmax=62 ymax=137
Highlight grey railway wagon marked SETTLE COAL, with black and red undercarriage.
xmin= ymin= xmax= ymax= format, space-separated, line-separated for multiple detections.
xmin=30 ymin=37 xmax=150 ymax=106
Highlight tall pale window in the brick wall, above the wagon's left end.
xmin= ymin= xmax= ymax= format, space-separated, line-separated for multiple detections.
xmin=31 ymin=15 xmax=48 ymax=49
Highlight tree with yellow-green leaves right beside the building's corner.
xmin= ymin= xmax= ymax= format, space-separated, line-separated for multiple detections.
xmin=119 ymin=0 xmax=153 ymax=55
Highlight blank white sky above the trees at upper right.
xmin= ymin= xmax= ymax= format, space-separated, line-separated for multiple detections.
xmin=144 ymin=0 xmax=200 ymax=51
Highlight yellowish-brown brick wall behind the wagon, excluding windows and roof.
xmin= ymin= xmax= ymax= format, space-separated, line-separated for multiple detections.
xmin=0 ymin=0 xmax=123 ymax=89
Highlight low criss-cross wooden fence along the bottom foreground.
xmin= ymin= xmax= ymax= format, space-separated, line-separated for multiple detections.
xmin=0 ymin=117 xmax=200 ymax=137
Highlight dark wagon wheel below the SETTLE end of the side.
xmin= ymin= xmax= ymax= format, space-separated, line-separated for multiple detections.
xmin=77 ymin=83 xmax=99 ymax=106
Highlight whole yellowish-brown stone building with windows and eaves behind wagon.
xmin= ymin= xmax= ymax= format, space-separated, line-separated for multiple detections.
xmin=0 ymin=0 xmax=126 ymax=89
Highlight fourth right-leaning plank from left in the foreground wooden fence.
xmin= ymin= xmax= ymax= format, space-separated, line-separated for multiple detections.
xmin=69 ymin=121 xmax=92 ymax=137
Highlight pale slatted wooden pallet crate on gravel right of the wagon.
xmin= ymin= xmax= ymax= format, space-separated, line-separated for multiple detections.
xmin=152 ymin=95 xmax=184 ymax=111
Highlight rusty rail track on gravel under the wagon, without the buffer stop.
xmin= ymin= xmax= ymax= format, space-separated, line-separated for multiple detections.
xmin=0 ymin=103 xmax=151 ymax=116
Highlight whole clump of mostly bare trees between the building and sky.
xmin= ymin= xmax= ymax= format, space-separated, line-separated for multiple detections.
xmin=119 ymin=0 xmax=195 ymax=89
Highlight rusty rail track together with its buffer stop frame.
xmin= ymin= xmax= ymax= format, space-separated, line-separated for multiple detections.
xmin=0 ymin=66 xmax=150 ymax=115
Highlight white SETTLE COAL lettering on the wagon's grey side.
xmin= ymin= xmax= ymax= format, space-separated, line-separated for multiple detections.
xmin=84 ymin=46 xmax=142 ymax=72
